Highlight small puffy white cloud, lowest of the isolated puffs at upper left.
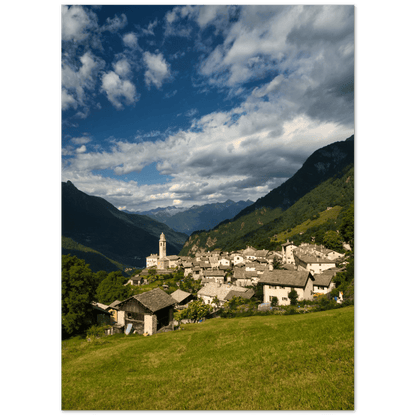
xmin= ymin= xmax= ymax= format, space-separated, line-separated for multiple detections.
xmin=101 ymin=71 xmax=138 ymax=110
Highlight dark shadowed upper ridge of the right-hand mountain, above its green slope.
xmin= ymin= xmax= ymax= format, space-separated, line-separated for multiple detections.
xmin=233 ymin=135 xmax=354 ymax=220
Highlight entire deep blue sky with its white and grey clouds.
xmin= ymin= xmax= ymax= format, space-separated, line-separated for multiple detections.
xmin=60 ymin=3 xmax=354 ymax=211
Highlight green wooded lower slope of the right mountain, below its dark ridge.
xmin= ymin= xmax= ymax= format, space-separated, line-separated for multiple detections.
xmin=180 ymin=166 xmax=354 ymax=255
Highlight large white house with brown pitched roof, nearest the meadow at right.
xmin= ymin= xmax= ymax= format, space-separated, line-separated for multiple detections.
xmin=259 ymin=270 xmax=315 ymax=305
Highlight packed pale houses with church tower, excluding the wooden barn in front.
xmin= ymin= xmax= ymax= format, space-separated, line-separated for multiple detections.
xmin=141 ymin=234 xmax=344 ymax=305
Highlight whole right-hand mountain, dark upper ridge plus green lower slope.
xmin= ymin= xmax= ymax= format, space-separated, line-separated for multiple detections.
xmin=180 ymin=136 xmax=355 ymax=255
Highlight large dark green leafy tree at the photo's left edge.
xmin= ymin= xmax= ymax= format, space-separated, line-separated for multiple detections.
xmin=61 ymin=254 xmax=96 ymax=337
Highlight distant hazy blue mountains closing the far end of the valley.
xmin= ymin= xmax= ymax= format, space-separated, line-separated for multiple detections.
xmin=127 ymin=199 xmax=253 ymax=235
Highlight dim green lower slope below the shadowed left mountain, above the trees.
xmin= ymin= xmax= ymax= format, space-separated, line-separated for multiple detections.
xmin=61 ymin=236 xmax=124 ymax=273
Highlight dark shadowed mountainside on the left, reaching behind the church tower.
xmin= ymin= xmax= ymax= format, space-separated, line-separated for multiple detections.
xmin=60 ymin=181 xmax=188 ymax=267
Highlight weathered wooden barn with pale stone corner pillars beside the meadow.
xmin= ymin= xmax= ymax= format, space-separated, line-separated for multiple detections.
xmin=117 ymin=288 xmax=176 ymax=335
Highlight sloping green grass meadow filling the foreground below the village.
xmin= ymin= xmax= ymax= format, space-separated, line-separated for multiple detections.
xmin=61 ymin=306 xmax=355 ymax=411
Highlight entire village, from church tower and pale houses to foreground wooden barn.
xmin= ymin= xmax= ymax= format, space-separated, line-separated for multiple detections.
xmin=93 ymin=233 xmax=344 ymax=335
